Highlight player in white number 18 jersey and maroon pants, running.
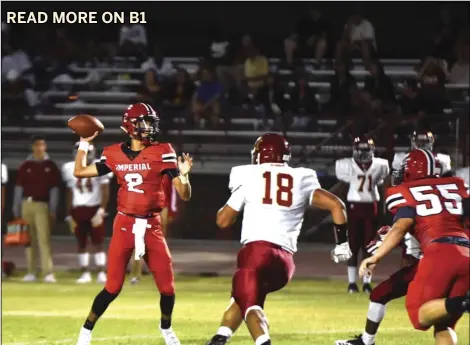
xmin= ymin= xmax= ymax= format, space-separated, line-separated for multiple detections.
xmin=208 ymin=133 xmax=351 ymax=345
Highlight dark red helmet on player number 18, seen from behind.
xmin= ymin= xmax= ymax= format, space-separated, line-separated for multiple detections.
xmin=251 ymin=133 xmax=291 ymax=164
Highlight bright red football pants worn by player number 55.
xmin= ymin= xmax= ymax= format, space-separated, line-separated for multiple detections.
xmin=406 ymin=243 xmax=470 ymax=331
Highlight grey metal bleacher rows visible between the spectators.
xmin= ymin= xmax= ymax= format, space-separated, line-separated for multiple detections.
xmin=2 ymin=57 xmax=469 ymax=173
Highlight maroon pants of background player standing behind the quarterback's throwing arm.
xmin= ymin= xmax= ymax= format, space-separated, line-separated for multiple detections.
xmin=70 ymin=206 xmax=105 ymax=251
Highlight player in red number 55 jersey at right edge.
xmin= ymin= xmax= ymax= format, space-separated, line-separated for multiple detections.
xmin=360 ymin=149 xmax=470 ymax=345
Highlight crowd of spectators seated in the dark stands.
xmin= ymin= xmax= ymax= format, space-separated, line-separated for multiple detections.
xmin=2 ymin=8 xmax=469 ymax=136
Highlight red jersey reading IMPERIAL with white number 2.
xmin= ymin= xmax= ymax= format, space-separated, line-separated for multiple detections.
xmin=101 ymin=143 xmax=177 ymax=216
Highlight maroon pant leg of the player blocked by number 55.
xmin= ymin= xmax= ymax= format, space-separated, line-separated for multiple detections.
xmin=370 ymin=262 xmax=418 ymax=305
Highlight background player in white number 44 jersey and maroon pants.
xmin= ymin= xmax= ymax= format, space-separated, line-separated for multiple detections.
xmin=62 ymin=142 xmax=113 ymax=284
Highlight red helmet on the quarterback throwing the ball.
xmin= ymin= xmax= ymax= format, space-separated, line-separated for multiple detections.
xmin=121 ymin=103 xmax=160 ymax=145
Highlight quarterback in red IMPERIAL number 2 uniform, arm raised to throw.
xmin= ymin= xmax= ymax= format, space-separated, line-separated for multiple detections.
xmin=74 ymin=103 xmax=192 ymax=345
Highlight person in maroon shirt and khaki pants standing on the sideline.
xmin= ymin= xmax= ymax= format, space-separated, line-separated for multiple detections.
xmin=13 ymin=136 xmax=60 ymax=283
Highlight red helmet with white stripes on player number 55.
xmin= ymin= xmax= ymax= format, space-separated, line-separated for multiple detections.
xmin=402 ymin=149 xmax=441 ymax=182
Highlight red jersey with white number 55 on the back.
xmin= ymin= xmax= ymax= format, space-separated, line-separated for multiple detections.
xmin=386 ymin=177 xmax=468 ymax=250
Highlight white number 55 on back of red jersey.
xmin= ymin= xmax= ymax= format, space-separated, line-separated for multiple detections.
xmin=410 ymin=183 xmax=463 ymax=217
